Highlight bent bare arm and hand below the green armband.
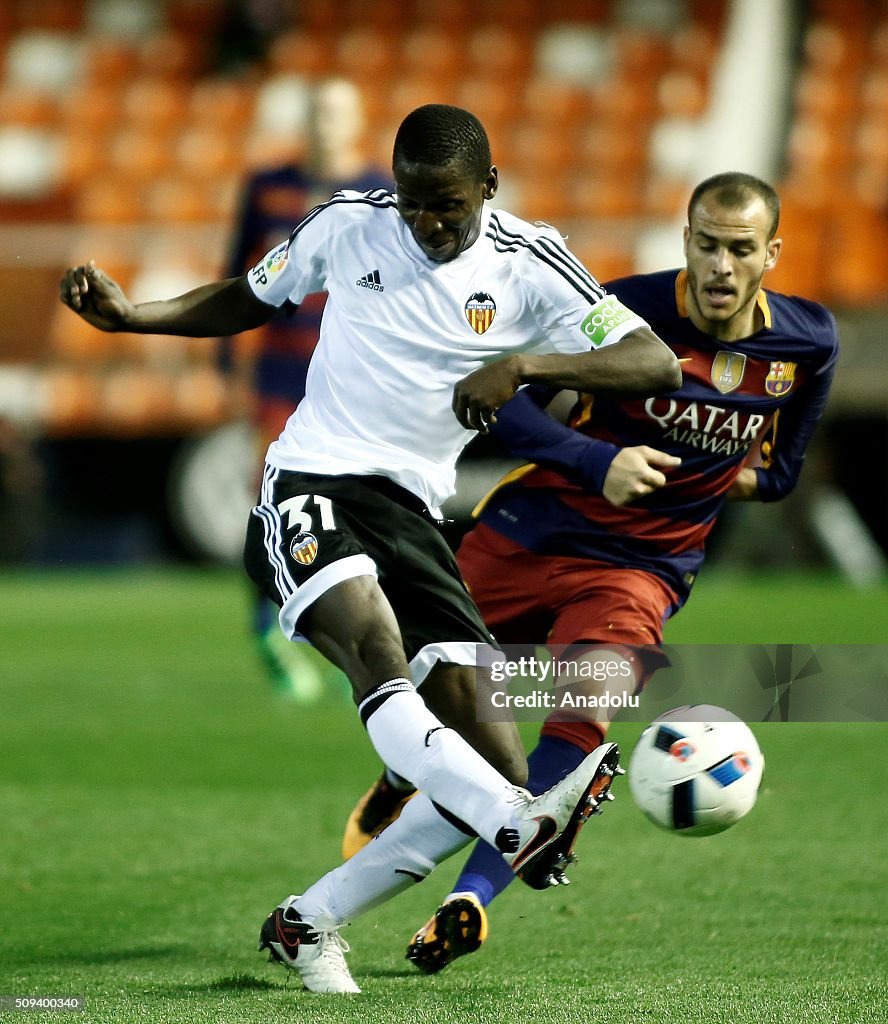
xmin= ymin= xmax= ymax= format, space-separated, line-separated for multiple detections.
xmin=453 ymin=328 xmax=681 ymax=433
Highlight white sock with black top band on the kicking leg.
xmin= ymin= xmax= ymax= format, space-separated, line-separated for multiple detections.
xmin=360 ymin=679 xmax=516 ymax=848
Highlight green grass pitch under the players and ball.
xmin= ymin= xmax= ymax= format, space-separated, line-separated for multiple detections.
xmin=0 ymin=570 xmax=888 ymax=1024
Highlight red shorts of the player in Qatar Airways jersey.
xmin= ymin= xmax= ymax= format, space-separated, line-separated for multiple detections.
xmin=457 ymin=523 xmax=679 ymax=753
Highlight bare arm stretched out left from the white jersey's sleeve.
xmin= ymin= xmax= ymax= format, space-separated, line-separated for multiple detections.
xmin=59 ymin=261 xmax=274 ymax=338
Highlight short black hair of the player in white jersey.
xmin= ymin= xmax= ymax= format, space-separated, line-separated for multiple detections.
xmin=392 ymin=103 xmax=491 ymax=181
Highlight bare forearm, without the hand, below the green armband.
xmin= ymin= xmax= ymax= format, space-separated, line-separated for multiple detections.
xmin=514 ymin=328 xmax=681 ymax=397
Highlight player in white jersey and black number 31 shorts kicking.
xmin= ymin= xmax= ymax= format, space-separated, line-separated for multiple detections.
xmin=61 ymin=104 xmax=680 ymax=992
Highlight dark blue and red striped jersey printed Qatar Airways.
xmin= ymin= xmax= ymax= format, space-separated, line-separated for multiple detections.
xmin=479 ymin=270 xmax=838 ymax=601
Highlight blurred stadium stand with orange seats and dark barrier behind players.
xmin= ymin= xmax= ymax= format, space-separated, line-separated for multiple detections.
xmin=0 ymin=0 xmax=888 ymax=577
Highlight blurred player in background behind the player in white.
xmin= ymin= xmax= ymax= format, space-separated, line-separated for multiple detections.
xmin=219 ymin=78 xmax=392 ymax=703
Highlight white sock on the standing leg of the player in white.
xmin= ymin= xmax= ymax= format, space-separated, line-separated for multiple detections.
xmin=294 ymin=793 xmax=471 ymax=931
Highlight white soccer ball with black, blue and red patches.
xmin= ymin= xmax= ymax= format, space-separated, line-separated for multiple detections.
xmin=629 ymin=705 xmax=765 ymax=836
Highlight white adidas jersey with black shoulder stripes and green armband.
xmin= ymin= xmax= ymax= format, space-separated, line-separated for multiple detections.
xmin=248 ymin=189 xmax=644 ymax=509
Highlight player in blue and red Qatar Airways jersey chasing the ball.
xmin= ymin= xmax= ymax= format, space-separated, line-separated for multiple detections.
xmin=344 ymin=172 xmax=838 ymax=973
